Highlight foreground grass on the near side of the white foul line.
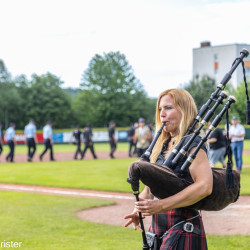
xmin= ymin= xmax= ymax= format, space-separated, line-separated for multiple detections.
xmin=0 ymin=191 xmax=250 ymax=250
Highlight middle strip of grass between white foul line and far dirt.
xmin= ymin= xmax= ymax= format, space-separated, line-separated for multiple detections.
xmin=0 ymin=158 xmax=250 ymax=195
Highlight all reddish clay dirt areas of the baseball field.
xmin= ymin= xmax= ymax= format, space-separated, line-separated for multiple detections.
xmin=0 ymin=149 xmax=250 ymax=235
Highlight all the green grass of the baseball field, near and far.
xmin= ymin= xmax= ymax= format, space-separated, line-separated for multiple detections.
xmin=0 ymin=141 xmax=250 ymax=250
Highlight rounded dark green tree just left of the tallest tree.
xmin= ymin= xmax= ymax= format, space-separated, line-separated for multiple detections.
xmin=20 ymin=73 xmax=74 ymax=128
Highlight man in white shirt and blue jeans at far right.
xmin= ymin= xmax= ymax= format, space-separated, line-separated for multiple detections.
xmin=229 ymin=116 xmax=246 ymax=172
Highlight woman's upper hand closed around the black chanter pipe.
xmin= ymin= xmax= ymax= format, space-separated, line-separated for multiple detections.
xmin=135 ymin=200 xmax=163 ymax=216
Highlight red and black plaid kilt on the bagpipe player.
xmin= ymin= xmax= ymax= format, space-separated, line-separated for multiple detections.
xmin=149 ymin=208 xmax=207 ymax=250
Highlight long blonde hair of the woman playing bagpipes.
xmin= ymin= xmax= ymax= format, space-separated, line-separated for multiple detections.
xmin=150 ymin=89 xmax=198 ymax=162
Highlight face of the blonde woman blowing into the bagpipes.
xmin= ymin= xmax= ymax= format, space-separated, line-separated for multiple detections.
xmin=159 ymin=95 xmax=181 ymax=136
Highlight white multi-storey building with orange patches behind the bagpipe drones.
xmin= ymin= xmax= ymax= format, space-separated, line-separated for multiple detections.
xmin=193 ymin=41 xmax=250 ymax=88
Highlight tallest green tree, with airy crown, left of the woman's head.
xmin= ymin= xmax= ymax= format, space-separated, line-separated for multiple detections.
xmin=78 ymin=52 xmax=155 ymax=126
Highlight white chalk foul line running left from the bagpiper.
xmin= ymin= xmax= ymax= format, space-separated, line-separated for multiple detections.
xmin=0 ymin=185 xmax=133 ymax=200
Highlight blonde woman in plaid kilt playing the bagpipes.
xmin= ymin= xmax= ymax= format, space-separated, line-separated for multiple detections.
xmin=124 ymin=89 xmax=213 ymax=250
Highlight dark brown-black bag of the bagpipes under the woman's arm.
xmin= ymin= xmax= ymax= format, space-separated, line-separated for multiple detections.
xmin=129 ymin=160 xmax=240 ymax=211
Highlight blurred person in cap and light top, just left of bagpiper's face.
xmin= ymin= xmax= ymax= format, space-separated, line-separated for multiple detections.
xmin=134 ymin=118 xmax=152 ymax=157
